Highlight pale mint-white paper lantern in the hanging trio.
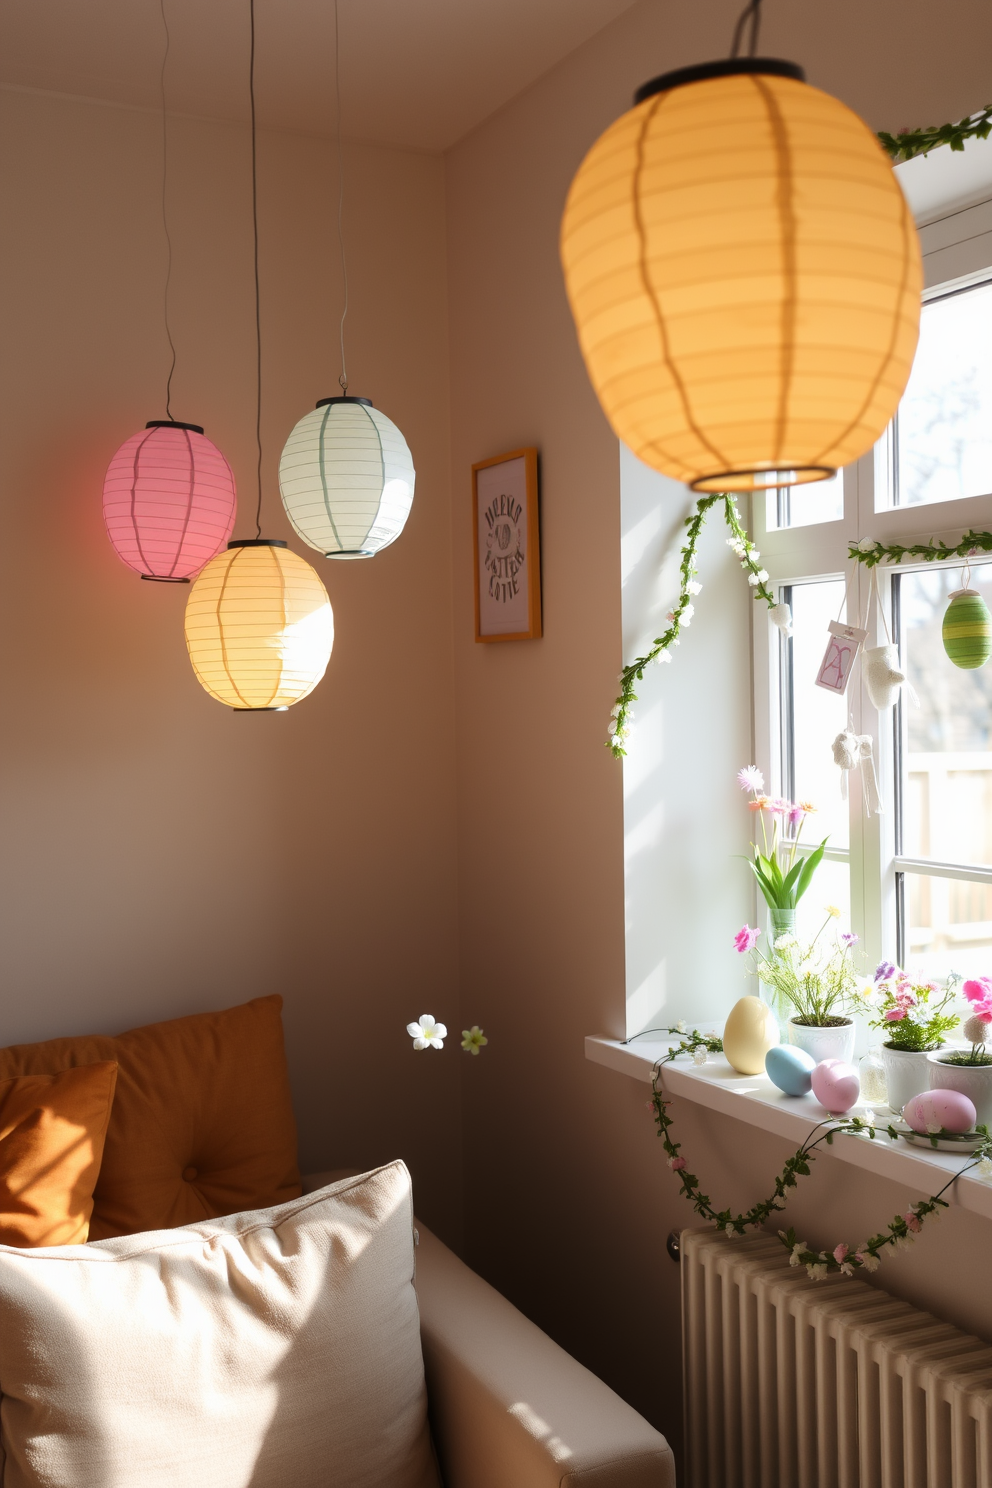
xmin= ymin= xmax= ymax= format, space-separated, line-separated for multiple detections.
xmin=280 ymin=397 xmax=415 ymax=558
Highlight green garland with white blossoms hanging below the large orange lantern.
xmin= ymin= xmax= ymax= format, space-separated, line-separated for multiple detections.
xmin=607 ymin=491 xmax=788 ymax=759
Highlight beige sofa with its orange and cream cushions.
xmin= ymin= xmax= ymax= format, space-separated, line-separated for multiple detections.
xmin=0 ymin=997 xmax=675 ymax=1488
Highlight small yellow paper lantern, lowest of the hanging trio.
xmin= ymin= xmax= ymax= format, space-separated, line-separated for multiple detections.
xmin=186 ymin=539 xmax=335 ymax=711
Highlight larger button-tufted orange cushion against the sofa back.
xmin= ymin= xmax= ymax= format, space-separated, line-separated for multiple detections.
xmin=0 ymin=997 xmax=302 ymax=1240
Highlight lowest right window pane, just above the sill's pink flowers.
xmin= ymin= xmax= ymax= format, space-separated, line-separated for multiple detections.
xmin=904 ymin=873 xmax=992 ymax=978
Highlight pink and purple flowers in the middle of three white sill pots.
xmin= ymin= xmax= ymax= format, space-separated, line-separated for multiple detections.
xmin=863 ymin=961 xmax=961 ymax=1113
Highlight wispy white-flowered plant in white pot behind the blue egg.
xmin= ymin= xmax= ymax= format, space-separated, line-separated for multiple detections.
xmin=735 ymin=906 xmax=858 ymax=1064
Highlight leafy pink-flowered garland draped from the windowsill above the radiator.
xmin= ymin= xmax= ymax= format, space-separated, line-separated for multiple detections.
xmin=647 ymin=1024 xmax=992 ymax=1280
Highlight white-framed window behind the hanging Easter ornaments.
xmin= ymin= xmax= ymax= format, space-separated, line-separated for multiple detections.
xmin=754 ymin=188 xmax=992 ymax=975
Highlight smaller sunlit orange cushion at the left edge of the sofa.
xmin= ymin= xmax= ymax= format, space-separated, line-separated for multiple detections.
xmin=0 ymin=1059 xmax=117 ymax=1248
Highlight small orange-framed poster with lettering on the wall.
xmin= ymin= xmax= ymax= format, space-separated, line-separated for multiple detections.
xmin=471 ymin=449 xmax=541 ymax=641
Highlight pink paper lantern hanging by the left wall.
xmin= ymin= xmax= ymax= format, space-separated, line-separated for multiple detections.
xmin=103 ymin=420 xmax=238 ymax=583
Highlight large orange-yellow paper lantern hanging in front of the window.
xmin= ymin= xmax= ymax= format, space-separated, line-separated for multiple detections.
xmin=561 ymin=58 xmax=922 ymax=491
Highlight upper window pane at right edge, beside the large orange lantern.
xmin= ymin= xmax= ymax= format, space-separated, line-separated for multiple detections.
xmin=895 ymin=284 xmax=992 ymax=506
